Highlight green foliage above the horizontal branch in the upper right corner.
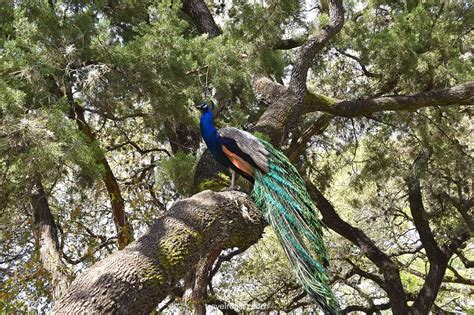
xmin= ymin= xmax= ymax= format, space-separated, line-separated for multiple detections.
xmin=317 ymin=1 xmax=473 ymax=98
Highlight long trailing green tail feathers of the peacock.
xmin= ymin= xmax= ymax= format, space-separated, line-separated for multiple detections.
xmin=251 ymin=139 xmax=340 ymax=314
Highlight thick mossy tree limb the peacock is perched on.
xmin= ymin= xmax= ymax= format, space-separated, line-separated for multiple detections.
xmin=53 ymin=191 xmax=263 ymax=314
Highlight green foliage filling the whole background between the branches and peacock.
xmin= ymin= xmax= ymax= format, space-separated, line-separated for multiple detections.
xmin=0 ymin=0 xmax=474 ymax=313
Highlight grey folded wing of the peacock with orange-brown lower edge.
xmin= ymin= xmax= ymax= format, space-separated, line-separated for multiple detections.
xmin=219 ymin=127 xmax=269 ymax=174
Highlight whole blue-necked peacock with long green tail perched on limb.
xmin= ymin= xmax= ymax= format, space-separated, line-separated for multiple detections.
xmin=197 ymin=102 xmax=340 ymax=314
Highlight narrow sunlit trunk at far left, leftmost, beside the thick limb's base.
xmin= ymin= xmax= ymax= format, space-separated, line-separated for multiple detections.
xmin=30 ymin=175 xmax=69 ymax=300
